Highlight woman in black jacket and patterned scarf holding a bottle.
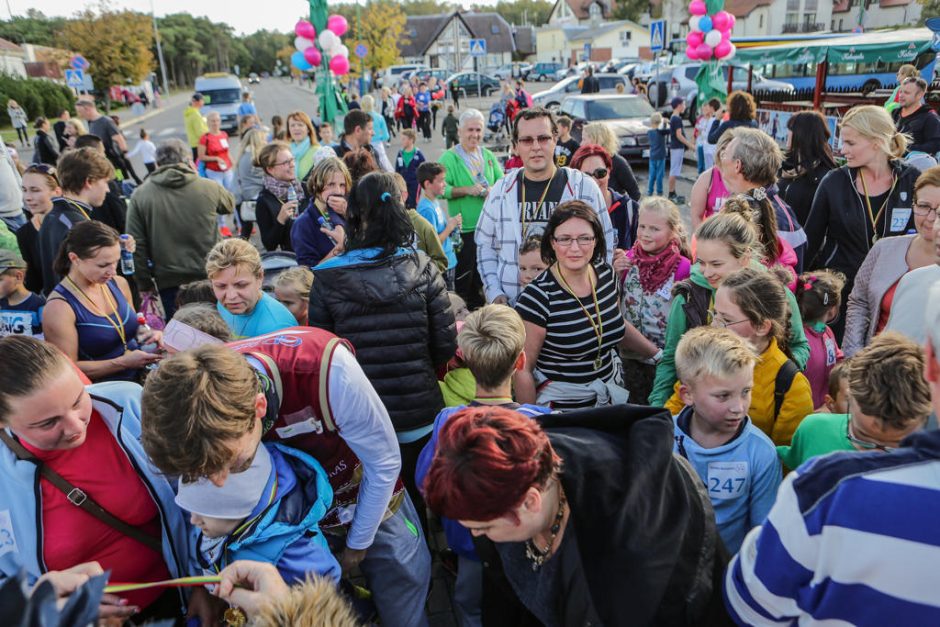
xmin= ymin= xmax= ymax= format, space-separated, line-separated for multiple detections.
xmin=255 ymin=141 xmax=304 ymax=251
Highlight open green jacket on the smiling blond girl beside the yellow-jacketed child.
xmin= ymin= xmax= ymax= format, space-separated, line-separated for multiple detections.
xmin=649 ymin=261 xmax=809 ymax=407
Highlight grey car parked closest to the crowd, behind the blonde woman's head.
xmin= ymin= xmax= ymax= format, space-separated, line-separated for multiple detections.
xmin=560 ymin=94 xmax=654 ymax=161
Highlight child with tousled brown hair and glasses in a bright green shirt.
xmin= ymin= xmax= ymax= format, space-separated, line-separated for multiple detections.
xmin=777 ymin=332 xmax=931 ymax=470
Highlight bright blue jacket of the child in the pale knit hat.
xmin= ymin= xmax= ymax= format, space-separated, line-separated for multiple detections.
xmin=193 ymin=442 xmax=340 ymax=585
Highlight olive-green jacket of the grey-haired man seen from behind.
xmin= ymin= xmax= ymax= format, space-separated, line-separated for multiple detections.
xmin=127 ymin=163 xmax=235 ymax=291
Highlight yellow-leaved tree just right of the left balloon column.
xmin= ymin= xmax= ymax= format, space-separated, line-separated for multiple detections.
xmin=346 ymin=0 xmax=406 ymax=76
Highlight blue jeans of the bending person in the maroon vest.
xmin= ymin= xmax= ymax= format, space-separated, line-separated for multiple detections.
xmin=359 ymin=494 xmax=431 ymax=627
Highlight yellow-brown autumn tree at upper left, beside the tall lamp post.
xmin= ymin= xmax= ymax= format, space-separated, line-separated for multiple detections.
xmin=62 ymin=3 xmax=153 ymax=110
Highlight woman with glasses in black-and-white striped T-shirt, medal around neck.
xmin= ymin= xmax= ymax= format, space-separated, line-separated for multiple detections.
xmin=514 ymin=200 xmax=659 ymax=410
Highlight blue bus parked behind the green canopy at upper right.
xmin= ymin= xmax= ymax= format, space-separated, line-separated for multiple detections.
xmin=732 ymin=28 xmax=940 ymax=94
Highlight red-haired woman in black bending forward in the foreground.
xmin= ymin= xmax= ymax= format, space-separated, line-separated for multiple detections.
xmin=425 ymin=405 xmax=729 ymax=627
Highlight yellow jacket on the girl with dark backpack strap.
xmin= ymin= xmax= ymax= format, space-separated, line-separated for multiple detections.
xmin=666 ymin=339 xmax=813 ymax=446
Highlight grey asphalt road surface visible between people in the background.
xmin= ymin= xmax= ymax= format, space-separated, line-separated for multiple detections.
xmin=114 ymin=78 xmax=695 ymax=224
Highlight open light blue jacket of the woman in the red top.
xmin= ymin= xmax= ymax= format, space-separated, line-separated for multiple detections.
xmin=0 ymin=381 xmax=190 ymax=592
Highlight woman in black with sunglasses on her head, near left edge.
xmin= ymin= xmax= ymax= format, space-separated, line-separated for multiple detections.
xmin=16 ymin=164 xmax=62 ymax=294
